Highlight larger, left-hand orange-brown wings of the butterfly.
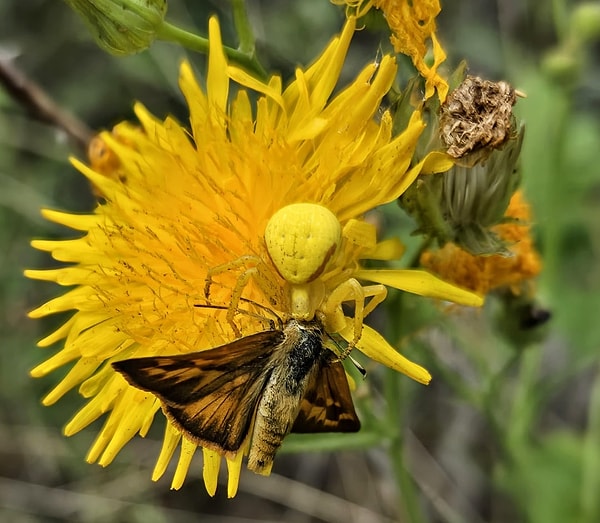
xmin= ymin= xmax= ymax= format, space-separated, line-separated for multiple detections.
xmin=113 ymin=330 xmax=284 ymax=455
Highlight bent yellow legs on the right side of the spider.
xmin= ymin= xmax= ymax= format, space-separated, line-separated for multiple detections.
xmin=321 ymin=278 xmax=387 ymax=359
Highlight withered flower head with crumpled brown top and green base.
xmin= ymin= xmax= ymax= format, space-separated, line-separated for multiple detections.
xmin=396 ymin=72 xmax=525 ymax=256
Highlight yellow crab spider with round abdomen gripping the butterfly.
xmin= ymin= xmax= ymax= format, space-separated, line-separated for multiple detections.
xmin=265 ymin=203 xmax=387 ymax=352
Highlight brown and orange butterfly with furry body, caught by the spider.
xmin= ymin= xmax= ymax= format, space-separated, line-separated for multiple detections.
xmin=112 ymin=319 xmax=360 ymax=474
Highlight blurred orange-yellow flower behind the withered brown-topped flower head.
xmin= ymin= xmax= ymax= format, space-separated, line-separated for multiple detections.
xmin=421 ymin=191 xmax=541 ymax=295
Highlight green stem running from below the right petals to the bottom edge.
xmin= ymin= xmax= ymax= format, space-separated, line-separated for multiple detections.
xmin=384 ymin=369 xmax=425 ymax=523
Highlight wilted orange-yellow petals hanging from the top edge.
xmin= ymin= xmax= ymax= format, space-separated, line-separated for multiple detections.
xmin=332 ymin=0 xmax=448 ymax=102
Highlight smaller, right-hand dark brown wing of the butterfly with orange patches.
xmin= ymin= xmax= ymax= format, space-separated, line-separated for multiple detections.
xmin=292 ymin=360 xmax=360 ymax=433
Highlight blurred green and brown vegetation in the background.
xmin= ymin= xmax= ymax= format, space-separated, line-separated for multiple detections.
xmin=0 ymin=0 xmax=600 ymax=523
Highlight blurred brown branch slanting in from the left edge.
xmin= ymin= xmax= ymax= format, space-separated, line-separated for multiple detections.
xmin=0 ymin=59 xmax=94 ymax=150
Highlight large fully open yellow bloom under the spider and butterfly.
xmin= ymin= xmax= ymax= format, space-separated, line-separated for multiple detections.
xmin=26 ymin=18 xmax=481 ymax=496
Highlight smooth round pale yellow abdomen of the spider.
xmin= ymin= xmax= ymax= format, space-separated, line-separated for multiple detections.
xmin=265 ymin=203 xmax=342 ymax=284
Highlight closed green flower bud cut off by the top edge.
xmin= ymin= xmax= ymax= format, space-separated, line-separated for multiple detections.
xmin=66 ymin=0 xmax=167 ymax=55
